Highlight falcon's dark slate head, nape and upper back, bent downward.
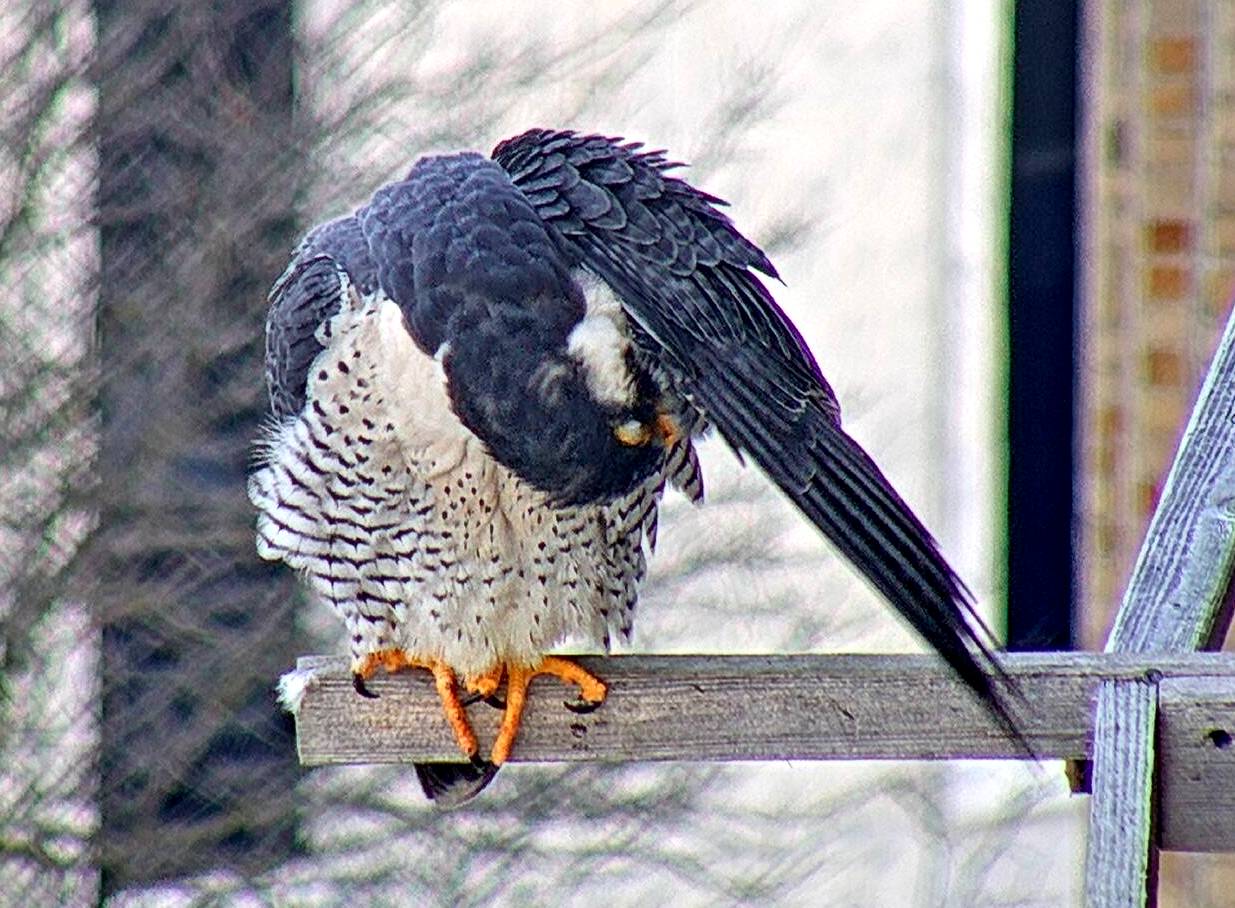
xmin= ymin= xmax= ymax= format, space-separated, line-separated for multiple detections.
xmin=357 ymin=152 xmax=659 ymax=504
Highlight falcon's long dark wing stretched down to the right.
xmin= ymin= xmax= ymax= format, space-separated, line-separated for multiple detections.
xmin=494 ymin=130 xmax=1011 ymax=728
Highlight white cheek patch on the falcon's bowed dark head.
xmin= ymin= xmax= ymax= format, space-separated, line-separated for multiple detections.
xmin=566 ymin=271 xmax=635 ymax=406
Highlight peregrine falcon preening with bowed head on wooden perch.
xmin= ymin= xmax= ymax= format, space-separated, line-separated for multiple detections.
xmin=249 ymin=130 xmax=1010 ymax=805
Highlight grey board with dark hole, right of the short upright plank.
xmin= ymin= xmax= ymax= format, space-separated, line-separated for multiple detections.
xmin=1158 ymin=678 xmax=1235 ymax=851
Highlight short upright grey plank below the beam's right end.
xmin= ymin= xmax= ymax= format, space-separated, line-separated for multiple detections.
xmin=1086 ymin=678 xmax=1155 ymax=908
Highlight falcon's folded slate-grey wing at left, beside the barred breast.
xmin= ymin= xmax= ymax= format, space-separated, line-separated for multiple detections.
xmin=266 ymin=217 xmax=377 ymax=419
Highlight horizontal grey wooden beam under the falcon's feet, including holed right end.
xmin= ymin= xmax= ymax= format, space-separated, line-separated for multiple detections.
xmin=284 ymin=654 xmax=1235 ymax=851
